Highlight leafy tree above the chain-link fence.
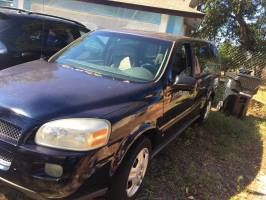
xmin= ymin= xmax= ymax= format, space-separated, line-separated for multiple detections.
xmin=195 ymin=0 xmax=266 ymax=51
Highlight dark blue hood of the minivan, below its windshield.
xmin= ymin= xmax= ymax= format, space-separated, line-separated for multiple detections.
xmin=0 ymin=61 xmax=151 ymax=121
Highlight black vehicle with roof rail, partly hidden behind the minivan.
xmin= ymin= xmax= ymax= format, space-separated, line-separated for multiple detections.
xmin=0 ymin=7 xmax=89 ymax=69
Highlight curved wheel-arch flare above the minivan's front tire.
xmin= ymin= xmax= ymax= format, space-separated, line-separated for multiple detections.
xmin=110 ymin=122 xmax=157 ymax=175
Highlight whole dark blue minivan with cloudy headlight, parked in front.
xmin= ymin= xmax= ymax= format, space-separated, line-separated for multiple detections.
xmin=0 ymin=30 xmax=218 ymax=200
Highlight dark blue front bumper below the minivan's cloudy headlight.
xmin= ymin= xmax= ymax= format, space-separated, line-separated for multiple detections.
xmin=0 ymin=141 xmax=111 ymax=199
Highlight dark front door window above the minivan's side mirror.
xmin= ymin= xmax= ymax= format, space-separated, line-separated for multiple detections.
xmin=172 ymin=44 xmax=192 ymax=80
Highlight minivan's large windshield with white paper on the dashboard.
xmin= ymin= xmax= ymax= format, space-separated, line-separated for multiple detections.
xmin=49 ymin=31 xmax=172 ymax=82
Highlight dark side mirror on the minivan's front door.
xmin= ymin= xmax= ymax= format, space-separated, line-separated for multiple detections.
xmin=174 ymin=75 xmax=197 ymax=91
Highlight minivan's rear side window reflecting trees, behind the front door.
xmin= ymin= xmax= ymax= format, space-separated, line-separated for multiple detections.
xmin=192 ymin=42 xmax=220 ymax=75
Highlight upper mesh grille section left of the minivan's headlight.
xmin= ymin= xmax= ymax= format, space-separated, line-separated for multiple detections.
xmin=0 ymin=119 xmax=22 ymax=145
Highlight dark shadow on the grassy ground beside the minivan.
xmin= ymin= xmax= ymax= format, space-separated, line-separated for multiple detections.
xmin=138 ymin=112 xmax=264 ymax=200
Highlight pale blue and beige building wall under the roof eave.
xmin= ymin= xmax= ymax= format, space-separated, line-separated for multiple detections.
xmin=15 ymin=0 xmax=184 ymax=35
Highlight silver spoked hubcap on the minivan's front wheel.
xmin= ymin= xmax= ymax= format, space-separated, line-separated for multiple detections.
xmin=126 ymin=148 xmax=149 ymax=197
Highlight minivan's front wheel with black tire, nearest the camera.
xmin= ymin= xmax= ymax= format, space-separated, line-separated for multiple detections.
xmin=107 ymin=138 xmax=151 ymax=200
